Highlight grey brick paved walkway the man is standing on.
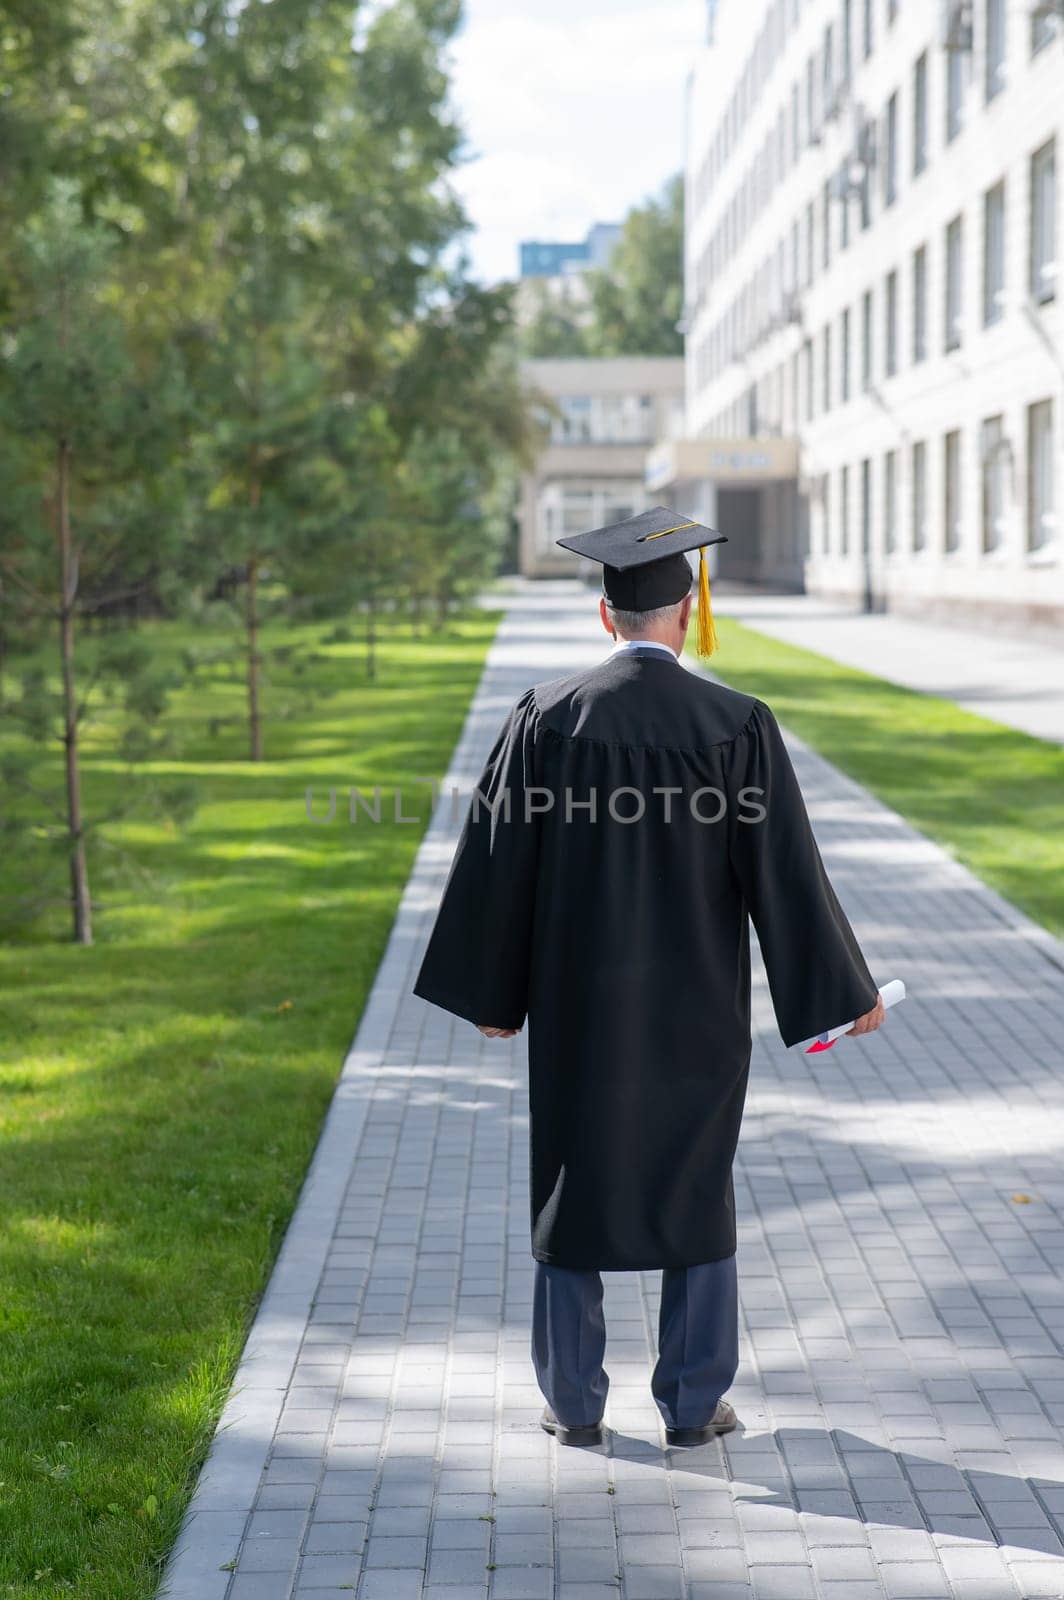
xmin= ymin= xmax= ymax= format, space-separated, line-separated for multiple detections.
xmin=165 ymin=584 xmax=1064 ymax=1600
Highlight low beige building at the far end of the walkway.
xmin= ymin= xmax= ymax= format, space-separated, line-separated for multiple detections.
xmin=518 ymin=355 xmax=683 ymax=578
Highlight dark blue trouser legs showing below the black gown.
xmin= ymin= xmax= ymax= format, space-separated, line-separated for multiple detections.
xmin=531 ymin=1256 xmax=739 ymax=1427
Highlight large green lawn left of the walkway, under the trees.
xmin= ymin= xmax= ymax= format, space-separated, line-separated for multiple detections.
xmin=0 ymin=614 xmax=498 ymax=1600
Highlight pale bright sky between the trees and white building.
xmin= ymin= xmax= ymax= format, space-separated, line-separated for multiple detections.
xmin=451 ymin=0 xmax=706 ymax=283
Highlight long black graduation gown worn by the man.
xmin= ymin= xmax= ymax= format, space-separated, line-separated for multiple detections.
xmin=414 ymin=650 xmax=877 ymax=1269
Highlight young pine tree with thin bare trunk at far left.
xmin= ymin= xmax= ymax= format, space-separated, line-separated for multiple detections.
xmin=0 ymin=187 xmax=181 ymax=944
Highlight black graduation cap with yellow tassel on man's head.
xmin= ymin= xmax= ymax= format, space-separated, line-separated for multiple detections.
xmin=555 ymin=506 xmax=728 ymax=656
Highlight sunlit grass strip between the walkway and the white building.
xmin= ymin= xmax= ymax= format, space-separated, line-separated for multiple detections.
xmin=694 ymin=618 xmax=1064 ymax=934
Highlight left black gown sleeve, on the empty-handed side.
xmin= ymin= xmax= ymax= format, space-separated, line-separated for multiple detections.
xmin=406 ymin=690 xmax=539 ymax=1027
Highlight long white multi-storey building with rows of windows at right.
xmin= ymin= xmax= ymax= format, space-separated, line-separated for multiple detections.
xmin=681 ymin=0 xmax=1064 ymax=626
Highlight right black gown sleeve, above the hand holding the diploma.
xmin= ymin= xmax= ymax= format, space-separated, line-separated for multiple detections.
xmin=722 ymin=701 xmax=878 ymax=1045
